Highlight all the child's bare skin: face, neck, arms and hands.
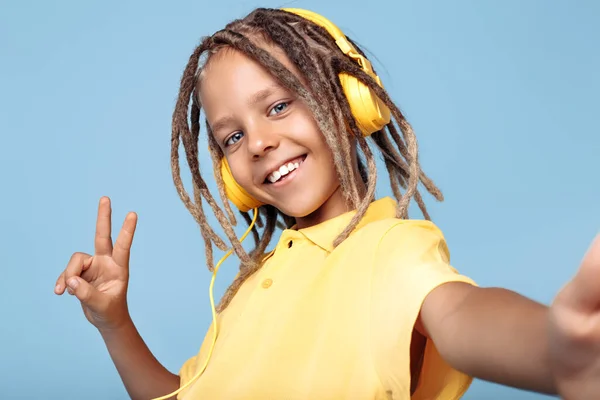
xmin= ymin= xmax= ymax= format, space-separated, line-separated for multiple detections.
xmin=55 ymin=41 xmax=600 ymax=400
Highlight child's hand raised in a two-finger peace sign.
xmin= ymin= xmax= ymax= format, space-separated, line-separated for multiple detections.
xmin=54 ymin=197 xmax=137 ymax=330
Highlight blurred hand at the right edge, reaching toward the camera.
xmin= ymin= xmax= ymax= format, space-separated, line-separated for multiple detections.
xmin=549 ymin=236 xmax=600 ymax=400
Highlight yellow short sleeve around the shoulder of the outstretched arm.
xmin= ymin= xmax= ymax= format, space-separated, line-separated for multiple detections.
xmin=371 ymin=220 xmax=475 ymax=400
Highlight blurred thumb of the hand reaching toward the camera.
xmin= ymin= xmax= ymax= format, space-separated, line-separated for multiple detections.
xmin=569 ymin=235 xmax=600 ymax=311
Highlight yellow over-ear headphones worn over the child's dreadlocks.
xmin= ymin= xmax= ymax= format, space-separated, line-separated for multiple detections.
xmin=221 ymin=8 xmax=390 ymax=212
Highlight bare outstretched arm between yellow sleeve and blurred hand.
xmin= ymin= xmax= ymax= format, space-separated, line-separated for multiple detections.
xmin=439 ymin=288 xmax=556 ymax=393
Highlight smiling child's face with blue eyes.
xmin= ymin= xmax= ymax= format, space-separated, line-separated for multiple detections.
xmin=200 ymin=47 xmax=345 ymax=225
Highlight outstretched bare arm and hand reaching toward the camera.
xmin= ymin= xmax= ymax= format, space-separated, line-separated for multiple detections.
xmin=417 ymin=236 xmax=600 ymax=400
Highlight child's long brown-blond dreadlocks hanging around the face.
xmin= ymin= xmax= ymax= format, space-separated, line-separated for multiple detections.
xmin=171 ymin=8 xmax=443 ymax=311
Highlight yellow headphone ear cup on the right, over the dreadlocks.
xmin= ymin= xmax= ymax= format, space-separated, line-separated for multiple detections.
xmin=339 ymin=73 xmax=390 ymax=136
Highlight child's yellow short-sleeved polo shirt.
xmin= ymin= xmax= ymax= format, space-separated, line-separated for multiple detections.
xmin=178 ymin=198 xmax=474 ymax=400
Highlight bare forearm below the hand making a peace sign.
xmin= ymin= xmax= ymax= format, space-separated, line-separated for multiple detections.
xmin=100 ymin=322 xmax=179 ymax=400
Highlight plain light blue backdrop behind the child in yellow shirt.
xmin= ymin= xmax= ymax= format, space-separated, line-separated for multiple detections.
xmin=0 ymin=0 xmax=600 ymax=399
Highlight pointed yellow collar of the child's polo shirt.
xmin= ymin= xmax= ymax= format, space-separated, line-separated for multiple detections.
xmin=291 ymin=197 xmax=396 ymax=252
